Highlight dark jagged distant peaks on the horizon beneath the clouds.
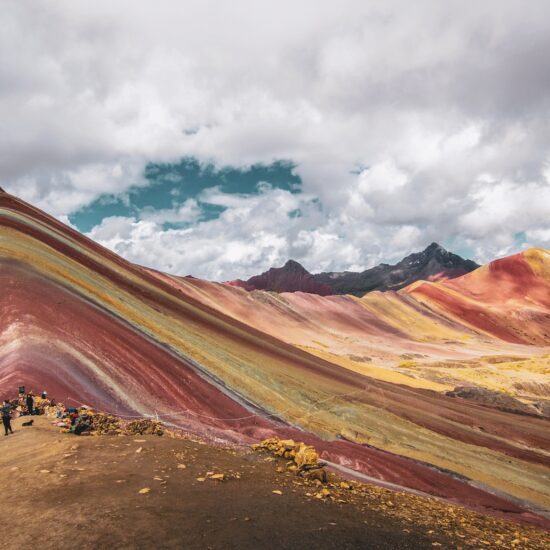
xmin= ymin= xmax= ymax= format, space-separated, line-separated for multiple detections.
xmin=226 ymin=243 xmax=479 ymax=296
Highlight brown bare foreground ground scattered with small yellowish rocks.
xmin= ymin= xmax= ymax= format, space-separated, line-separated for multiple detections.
xmin=0 ymin=417 xmax=550 ymax=549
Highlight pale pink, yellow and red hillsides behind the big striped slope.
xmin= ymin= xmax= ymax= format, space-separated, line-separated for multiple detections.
xmin=176 ymin=258 xmax=550 ymax=401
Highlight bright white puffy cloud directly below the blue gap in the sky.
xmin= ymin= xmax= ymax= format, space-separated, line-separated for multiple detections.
xmin=88 ymin=188 xmax=376 ymax=280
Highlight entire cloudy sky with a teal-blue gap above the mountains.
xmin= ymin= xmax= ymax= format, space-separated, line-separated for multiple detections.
xmin=0 ymin=0 xmax=550 ymax=280
